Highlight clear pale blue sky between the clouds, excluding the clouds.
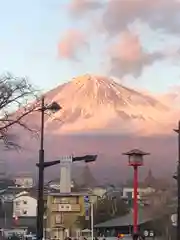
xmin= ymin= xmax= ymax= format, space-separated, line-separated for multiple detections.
xmin=0 ymin=0 xmax=180 ymax=92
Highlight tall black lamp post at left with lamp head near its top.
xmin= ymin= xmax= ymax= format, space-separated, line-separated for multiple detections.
xmin=37 ymin=96 xmax=61 ymax=240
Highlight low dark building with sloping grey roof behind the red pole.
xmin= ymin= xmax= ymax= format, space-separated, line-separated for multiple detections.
xmin=94 ymin=208 xmax=169 ymax=239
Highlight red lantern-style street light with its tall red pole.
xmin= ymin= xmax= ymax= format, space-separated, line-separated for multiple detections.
xmin=123 ymin=149 xmax=149 ymax=235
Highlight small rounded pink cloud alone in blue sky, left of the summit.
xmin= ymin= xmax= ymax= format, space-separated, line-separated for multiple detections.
xmin=58 ymin=29 xmax=87 ymax=60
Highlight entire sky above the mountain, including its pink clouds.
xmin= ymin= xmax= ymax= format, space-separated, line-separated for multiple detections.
xmin=0 ymin=0 xmax=180 ymax=92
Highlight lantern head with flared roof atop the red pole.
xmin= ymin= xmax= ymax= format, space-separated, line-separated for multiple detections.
xmin=123 ymin=149 xmax=150 ymax=167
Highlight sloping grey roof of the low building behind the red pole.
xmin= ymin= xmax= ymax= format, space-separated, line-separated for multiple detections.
xmin=95 ymin=208 xmax=165 ymax=228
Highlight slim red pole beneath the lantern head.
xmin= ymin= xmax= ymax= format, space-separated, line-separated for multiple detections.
xmin=133 ymin=166 xmax=138 ymax=233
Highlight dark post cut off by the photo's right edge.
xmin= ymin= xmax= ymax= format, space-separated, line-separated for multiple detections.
xmin=174 ymin=121 xmax=180 ymax=240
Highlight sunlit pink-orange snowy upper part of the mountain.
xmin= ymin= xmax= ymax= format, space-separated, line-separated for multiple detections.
xmin=40 ymin=74 xmax=170 ymax=134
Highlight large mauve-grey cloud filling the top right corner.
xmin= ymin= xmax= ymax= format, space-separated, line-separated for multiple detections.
xmin=102 ymin=0 xmax=180 ymax=35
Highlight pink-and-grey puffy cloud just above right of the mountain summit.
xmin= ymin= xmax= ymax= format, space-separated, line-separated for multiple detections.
xmin=110 ymin=31 xmax=164 ymax=77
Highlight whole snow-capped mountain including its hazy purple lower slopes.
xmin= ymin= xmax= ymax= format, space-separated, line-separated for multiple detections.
xmin=1 ymin=74 xmax=179 ymax=179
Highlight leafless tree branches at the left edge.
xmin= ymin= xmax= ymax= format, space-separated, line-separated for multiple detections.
xmin=0 ymin=74 xmax=39 ymax=148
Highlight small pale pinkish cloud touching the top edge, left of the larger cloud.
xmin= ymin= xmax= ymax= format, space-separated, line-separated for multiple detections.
xmin=69 ymin=0 xmax=102 ymax=17
